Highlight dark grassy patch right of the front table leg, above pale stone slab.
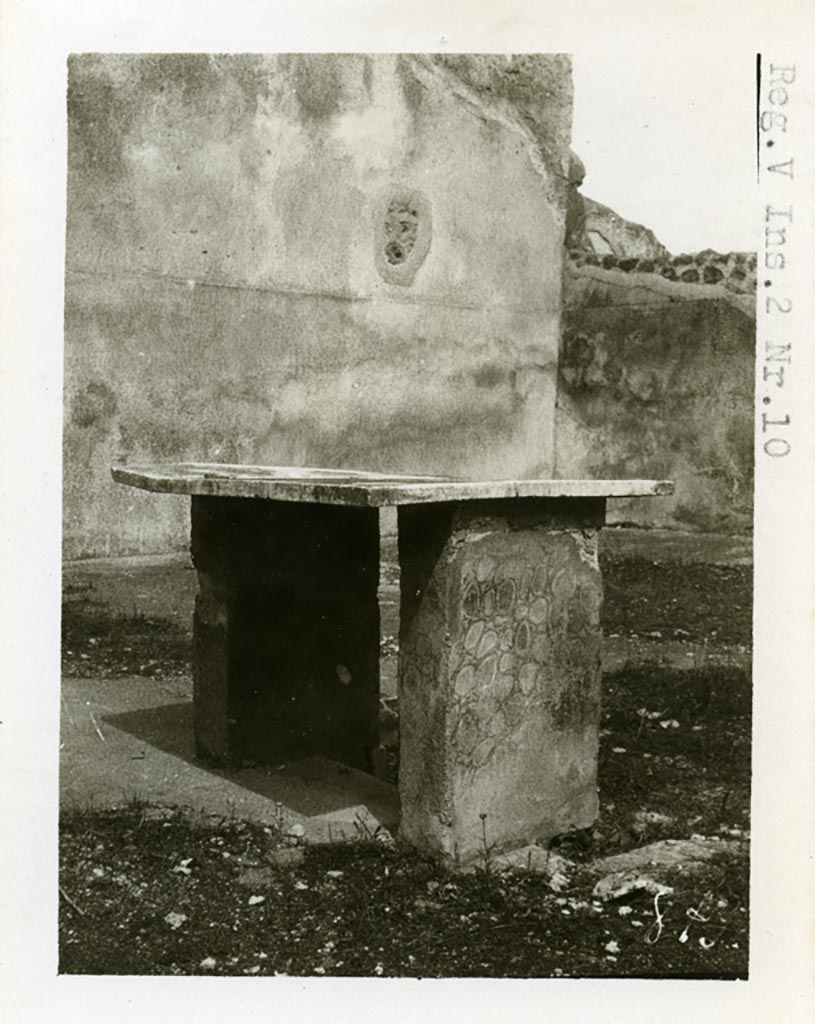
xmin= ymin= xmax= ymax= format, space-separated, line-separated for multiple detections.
xmin=592 ymin=666 xmax=753 ymax=856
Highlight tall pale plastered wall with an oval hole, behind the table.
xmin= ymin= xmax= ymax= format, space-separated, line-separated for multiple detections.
xmin=63 ymin=54 xmax=571 ymax=558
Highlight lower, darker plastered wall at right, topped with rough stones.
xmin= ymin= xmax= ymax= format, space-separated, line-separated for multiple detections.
xmin=556 ymin=264 xmax=756 ymax=531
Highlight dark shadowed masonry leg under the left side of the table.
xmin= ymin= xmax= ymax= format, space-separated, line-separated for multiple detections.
xmin=192 ymin=497 xmax=379 ymax=770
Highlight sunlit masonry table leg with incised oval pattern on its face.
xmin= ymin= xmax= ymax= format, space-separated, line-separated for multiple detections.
xmin=398 ymin=499 xmax=605 ymax=861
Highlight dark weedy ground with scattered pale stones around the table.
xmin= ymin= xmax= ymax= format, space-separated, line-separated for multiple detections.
xmin=59 ymin=544 xmax=752 ymax=978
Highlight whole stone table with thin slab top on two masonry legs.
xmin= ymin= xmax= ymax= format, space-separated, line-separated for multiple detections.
xmin=113 ymin=464 xmax=673 ymax=860
